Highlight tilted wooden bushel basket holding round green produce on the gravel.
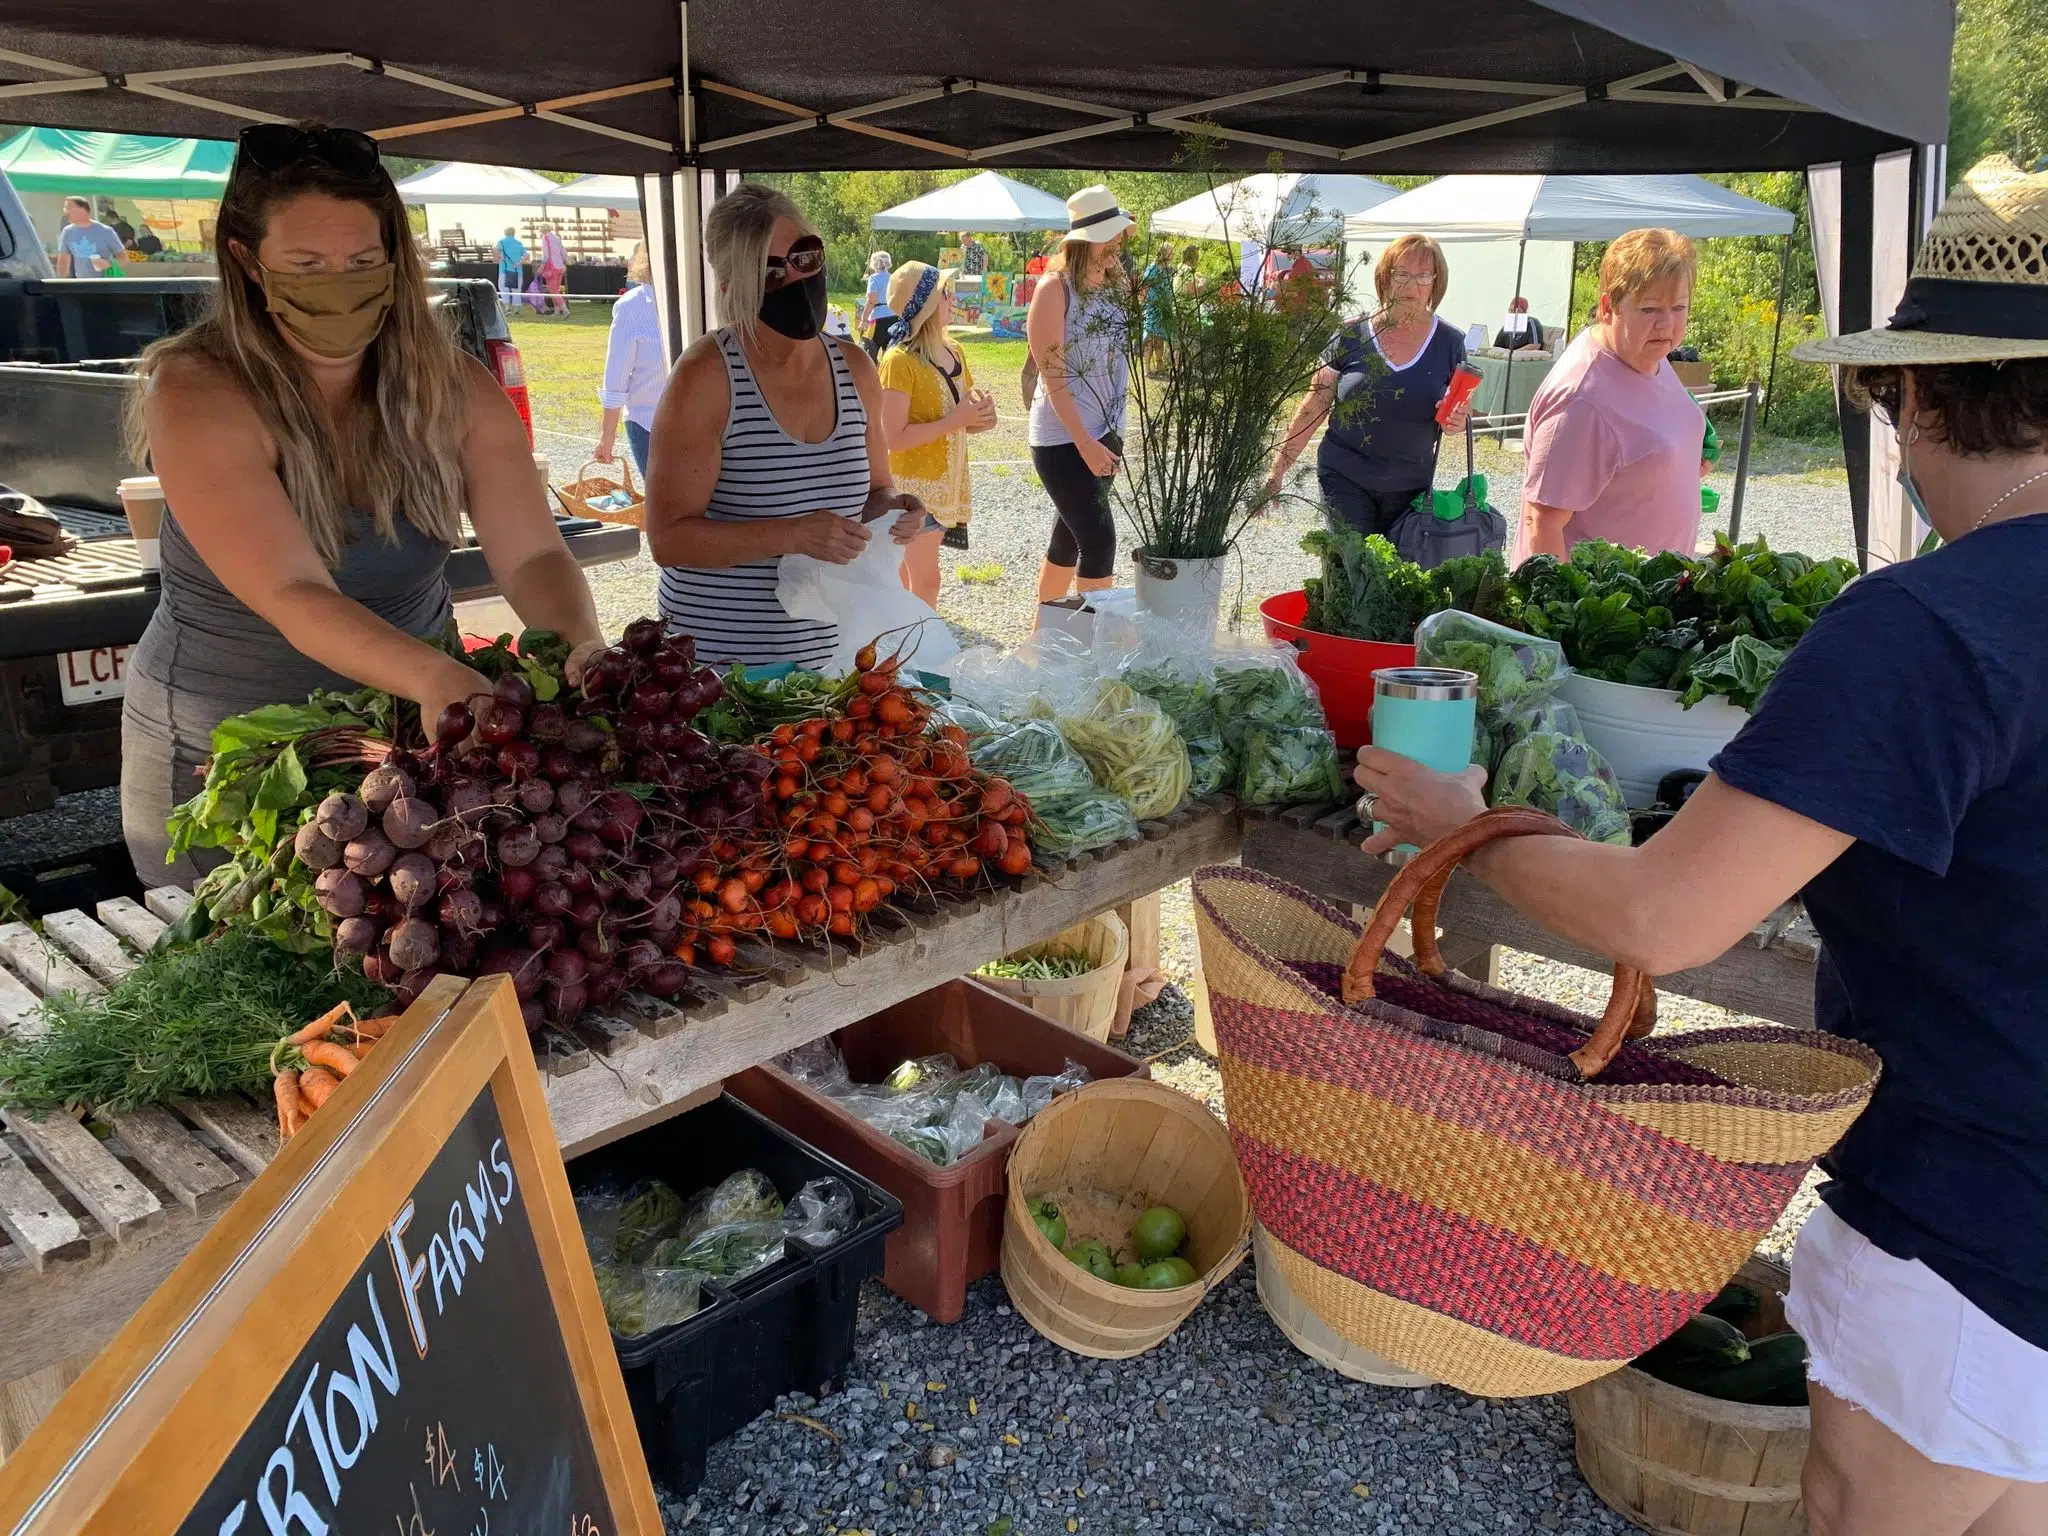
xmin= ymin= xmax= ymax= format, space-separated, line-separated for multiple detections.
xmin=1004 ymin=1077 xmax=1251 ymax=1360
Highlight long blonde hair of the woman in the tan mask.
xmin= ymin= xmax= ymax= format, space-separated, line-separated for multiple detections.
xmin=127 ymin=141 xmax=469 ymax=571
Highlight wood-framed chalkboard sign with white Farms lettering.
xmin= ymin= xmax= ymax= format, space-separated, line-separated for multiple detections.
xmin=0 ymin=979 xmax=662 ymax=1536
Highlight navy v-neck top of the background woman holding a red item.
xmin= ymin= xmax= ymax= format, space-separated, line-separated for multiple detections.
xmin=1315 ymin=319 xmax=1464 ymax=492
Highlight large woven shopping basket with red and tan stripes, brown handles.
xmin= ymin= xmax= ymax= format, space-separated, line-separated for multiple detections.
xmin=1194 ymin=811 xmax=1878 ymax=1397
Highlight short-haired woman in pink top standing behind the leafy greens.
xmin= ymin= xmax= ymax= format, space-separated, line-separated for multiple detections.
xmin=1518 ymin=229 xmax=1706 ymax=559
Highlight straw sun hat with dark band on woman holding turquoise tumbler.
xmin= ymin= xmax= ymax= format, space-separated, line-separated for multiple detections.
xmin=1792 ymin=156 xmax=2048 ymax=367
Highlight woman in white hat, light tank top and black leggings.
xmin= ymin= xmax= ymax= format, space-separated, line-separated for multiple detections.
xmin=1024 ymin=186 xmax=1133 ymax=602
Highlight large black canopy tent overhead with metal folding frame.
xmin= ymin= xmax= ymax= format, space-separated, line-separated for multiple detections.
xmin=0 ymin=0 xmax=1954 ymax=565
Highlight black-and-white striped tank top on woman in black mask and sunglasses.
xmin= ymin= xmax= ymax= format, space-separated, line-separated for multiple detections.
xmin=662 ymin=328 xmax=872 ymax=668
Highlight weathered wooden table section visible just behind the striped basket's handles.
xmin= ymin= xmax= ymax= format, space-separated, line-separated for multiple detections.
xmin=1243 ymin=803 xmax=1821 ymax=1028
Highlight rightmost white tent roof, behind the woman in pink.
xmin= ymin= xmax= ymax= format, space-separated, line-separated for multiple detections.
xmin=1343 ymin=176 xmax=1792 ymax=242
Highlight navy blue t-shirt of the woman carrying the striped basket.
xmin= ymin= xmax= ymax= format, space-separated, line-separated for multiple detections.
xmin=1714 ymin=514 xmax=2048 ymax=1350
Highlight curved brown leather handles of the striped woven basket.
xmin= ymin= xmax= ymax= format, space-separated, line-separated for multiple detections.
xmin=1343 ymin=805 xmax=1657 ymax=1079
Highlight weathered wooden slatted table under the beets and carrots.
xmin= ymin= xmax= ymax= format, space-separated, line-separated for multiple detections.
xmin=0 ymin=799 xmax=1241 ymax=1456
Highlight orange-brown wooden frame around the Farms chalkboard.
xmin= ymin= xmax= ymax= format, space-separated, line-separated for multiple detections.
xmin=0 ymin=977 xmax=662 ymax=1536
